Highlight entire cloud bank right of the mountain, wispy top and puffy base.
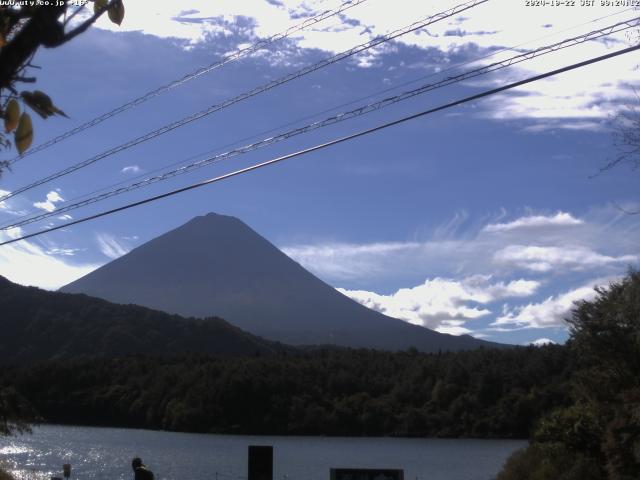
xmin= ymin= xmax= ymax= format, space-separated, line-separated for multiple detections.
xmin=283 ymin=207 xmax=640 ymax=336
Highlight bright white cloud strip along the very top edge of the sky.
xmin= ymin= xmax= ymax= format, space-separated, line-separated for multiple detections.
xmin=104 ymin=0 xmax=633 ymax=56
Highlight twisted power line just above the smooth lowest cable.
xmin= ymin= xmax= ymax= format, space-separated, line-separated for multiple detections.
xmin=0 ymin=17 xmax=640 ymax=230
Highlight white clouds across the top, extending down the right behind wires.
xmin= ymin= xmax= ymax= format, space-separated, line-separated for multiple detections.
xmin=81 ymin=0 xmax=637 ymax=126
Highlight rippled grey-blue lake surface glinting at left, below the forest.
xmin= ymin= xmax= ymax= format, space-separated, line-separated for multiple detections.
xmin=0 ymin=426 xmax=525 ymax=480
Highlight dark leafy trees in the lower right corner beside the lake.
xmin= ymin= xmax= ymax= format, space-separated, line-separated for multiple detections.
xmin=498 ymin=270 xmax=640 ymax=480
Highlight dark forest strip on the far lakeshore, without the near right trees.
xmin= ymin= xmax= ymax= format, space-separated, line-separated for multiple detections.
xmin=0 ymin=346 xmax=572 ymax=438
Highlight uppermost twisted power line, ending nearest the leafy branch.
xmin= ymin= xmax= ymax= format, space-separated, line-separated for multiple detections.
xmin=9 ymin=0 xmax=367 ymax=165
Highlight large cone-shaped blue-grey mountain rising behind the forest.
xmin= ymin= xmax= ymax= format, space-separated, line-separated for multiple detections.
xmin=61 ymin=213 xmax=502 ymax=352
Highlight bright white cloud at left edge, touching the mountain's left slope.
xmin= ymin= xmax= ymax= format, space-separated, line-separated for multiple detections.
xmin=0 ymin=228 xmax=98 ymax=290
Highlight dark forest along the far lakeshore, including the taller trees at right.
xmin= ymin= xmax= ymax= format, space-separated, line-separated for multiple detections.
xmin=0 ymin=271 xmax=640 ymax=480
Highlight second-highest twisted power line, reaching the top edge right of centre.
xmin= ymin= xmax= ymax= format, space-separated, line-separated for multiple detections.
xmin=0 ymin=0 xmax=489 ymax=202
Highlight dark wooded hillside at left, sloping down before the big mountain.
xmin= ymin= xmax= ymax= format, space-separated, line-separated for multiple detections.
xmin=0 ymin=276 xmax=288 ymax=363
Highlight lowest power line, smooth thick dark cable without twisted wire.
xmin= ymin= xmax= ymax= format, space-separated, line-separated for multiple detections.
xmin=0 ymin=44 xmax=640 ymax=246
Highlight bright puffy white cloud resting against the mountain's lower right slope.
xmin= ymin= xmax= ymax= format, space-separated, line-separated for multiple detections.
xmin=338 ymin=275 xmax=540 ymax=335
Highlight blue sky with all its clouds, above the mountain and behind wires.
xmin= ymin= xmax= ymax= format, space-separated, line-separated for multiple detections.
xmin=0 ymin=0 xmax=640 ymax=343
